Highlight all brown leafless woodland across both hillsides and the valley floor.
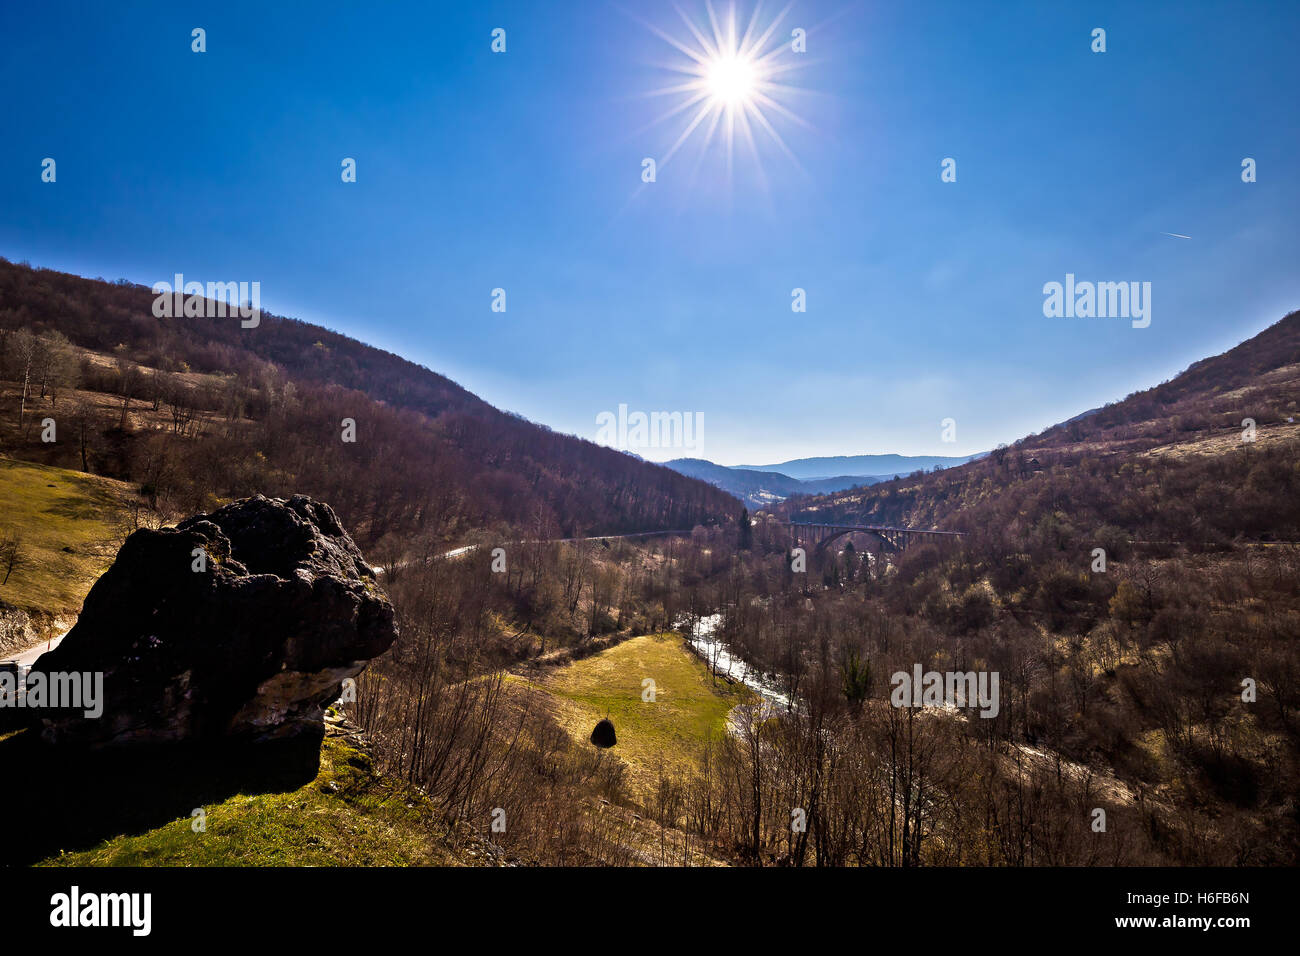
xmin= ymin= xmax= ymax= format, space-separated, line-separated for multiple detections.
xmin=0 ymin=254 xmax=1300 ymax=866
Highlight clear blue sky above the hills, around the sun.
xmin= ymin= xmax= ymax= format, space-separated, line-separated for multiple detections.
xmin=0 ymin=0 xmax=1300 ymax=464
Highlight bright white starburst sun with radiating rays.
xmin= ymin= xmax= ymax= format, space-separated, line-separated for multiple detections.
xmin=634 ymin=0 xmax=807 ymax=182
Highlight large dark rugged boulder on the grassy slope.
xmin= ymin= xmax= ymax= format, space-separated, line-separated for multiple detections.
xmin=29 ymin=496 xmax=397 ymax=752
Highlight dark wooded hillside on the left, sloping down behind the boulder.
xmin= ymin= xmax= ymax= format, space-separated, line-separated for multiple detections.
xmin=0 ymin=260 xmax=738 ymax=545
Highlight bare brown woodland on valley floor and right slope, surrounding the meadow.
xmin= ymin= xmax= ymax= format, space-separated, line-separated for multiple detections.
xmin=345 ymin=313 xmax=1300 ymax=866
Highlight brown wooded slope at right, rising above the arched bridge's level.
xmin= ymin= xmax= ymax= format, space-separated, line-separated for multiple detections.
xmin=785 ymin=312 xmax=1300 ymax=548
